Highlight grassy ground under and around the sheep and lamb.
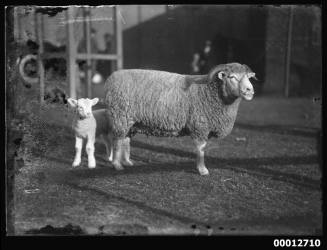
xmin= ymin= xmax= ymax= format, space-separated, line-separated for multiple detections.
xmin=9 ymin=94 xmax=322 ymax=235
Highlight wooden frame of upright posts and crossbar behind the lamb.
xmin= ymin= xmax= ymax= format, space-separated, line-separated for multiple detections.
xmin=35 ymin=5 xmax=123 ymax=103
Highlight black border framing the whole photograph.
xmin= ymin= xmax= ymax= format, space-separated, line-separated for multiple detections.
xmin=1 ymin=0 xmax=327 ymax=249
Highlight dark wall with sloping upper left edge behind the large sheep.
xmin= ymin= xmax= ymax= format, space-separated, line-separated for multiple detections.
xmin=123 ymin=5 xmax=266 ymax=94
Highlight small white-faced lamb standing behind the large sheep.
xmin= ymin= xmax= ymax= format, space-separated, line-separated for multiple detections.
xmin=67 ymin=98 xmax=118 ymax=168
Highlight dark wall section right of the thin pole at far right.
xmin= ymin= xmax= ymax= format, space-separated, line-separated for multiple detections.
xmin=290 ymin=7 xmax=322 ymax=96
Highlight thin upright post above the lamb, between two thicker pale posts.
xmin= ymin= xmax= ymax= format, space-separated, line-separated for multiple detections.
xmin=84 ymin=7 xmax=93 ymax=98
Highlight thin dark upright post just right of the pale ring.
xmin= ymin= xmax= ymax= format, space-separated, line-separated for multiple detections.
xmin=34 ymin=8 xmax=44 ymax=104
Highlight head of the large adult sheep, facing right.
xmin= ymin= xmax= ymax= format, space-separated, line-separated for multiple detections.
xmin=208 ymin=63 xmax=256 ymax=100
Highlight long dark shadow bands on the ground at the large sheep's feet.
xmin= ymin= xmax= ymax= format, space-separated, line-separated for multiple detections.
xmin=47 ymin=137 xmax=321 ymax=190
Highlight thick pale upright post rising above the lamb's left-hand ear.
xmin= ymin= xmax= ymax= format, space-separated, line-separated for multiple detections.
xmin=66 ymin=6 xmax=76 ymax=99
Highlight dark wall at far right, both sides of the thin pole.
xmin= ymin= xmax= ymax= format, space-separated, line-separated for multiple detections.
xmin=264 ymin=5 xmax=322 ymax=96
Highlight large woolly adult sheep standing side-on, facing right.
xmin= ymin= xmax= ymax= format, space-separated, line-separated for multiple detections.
xmin=105 ymin=63 xmax=256 ymax=175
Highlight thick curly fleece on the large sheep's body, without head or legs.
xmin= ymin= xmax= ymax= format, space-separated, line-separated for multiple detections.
xmin=105 ymin=69 xmax=244 ymax=140
